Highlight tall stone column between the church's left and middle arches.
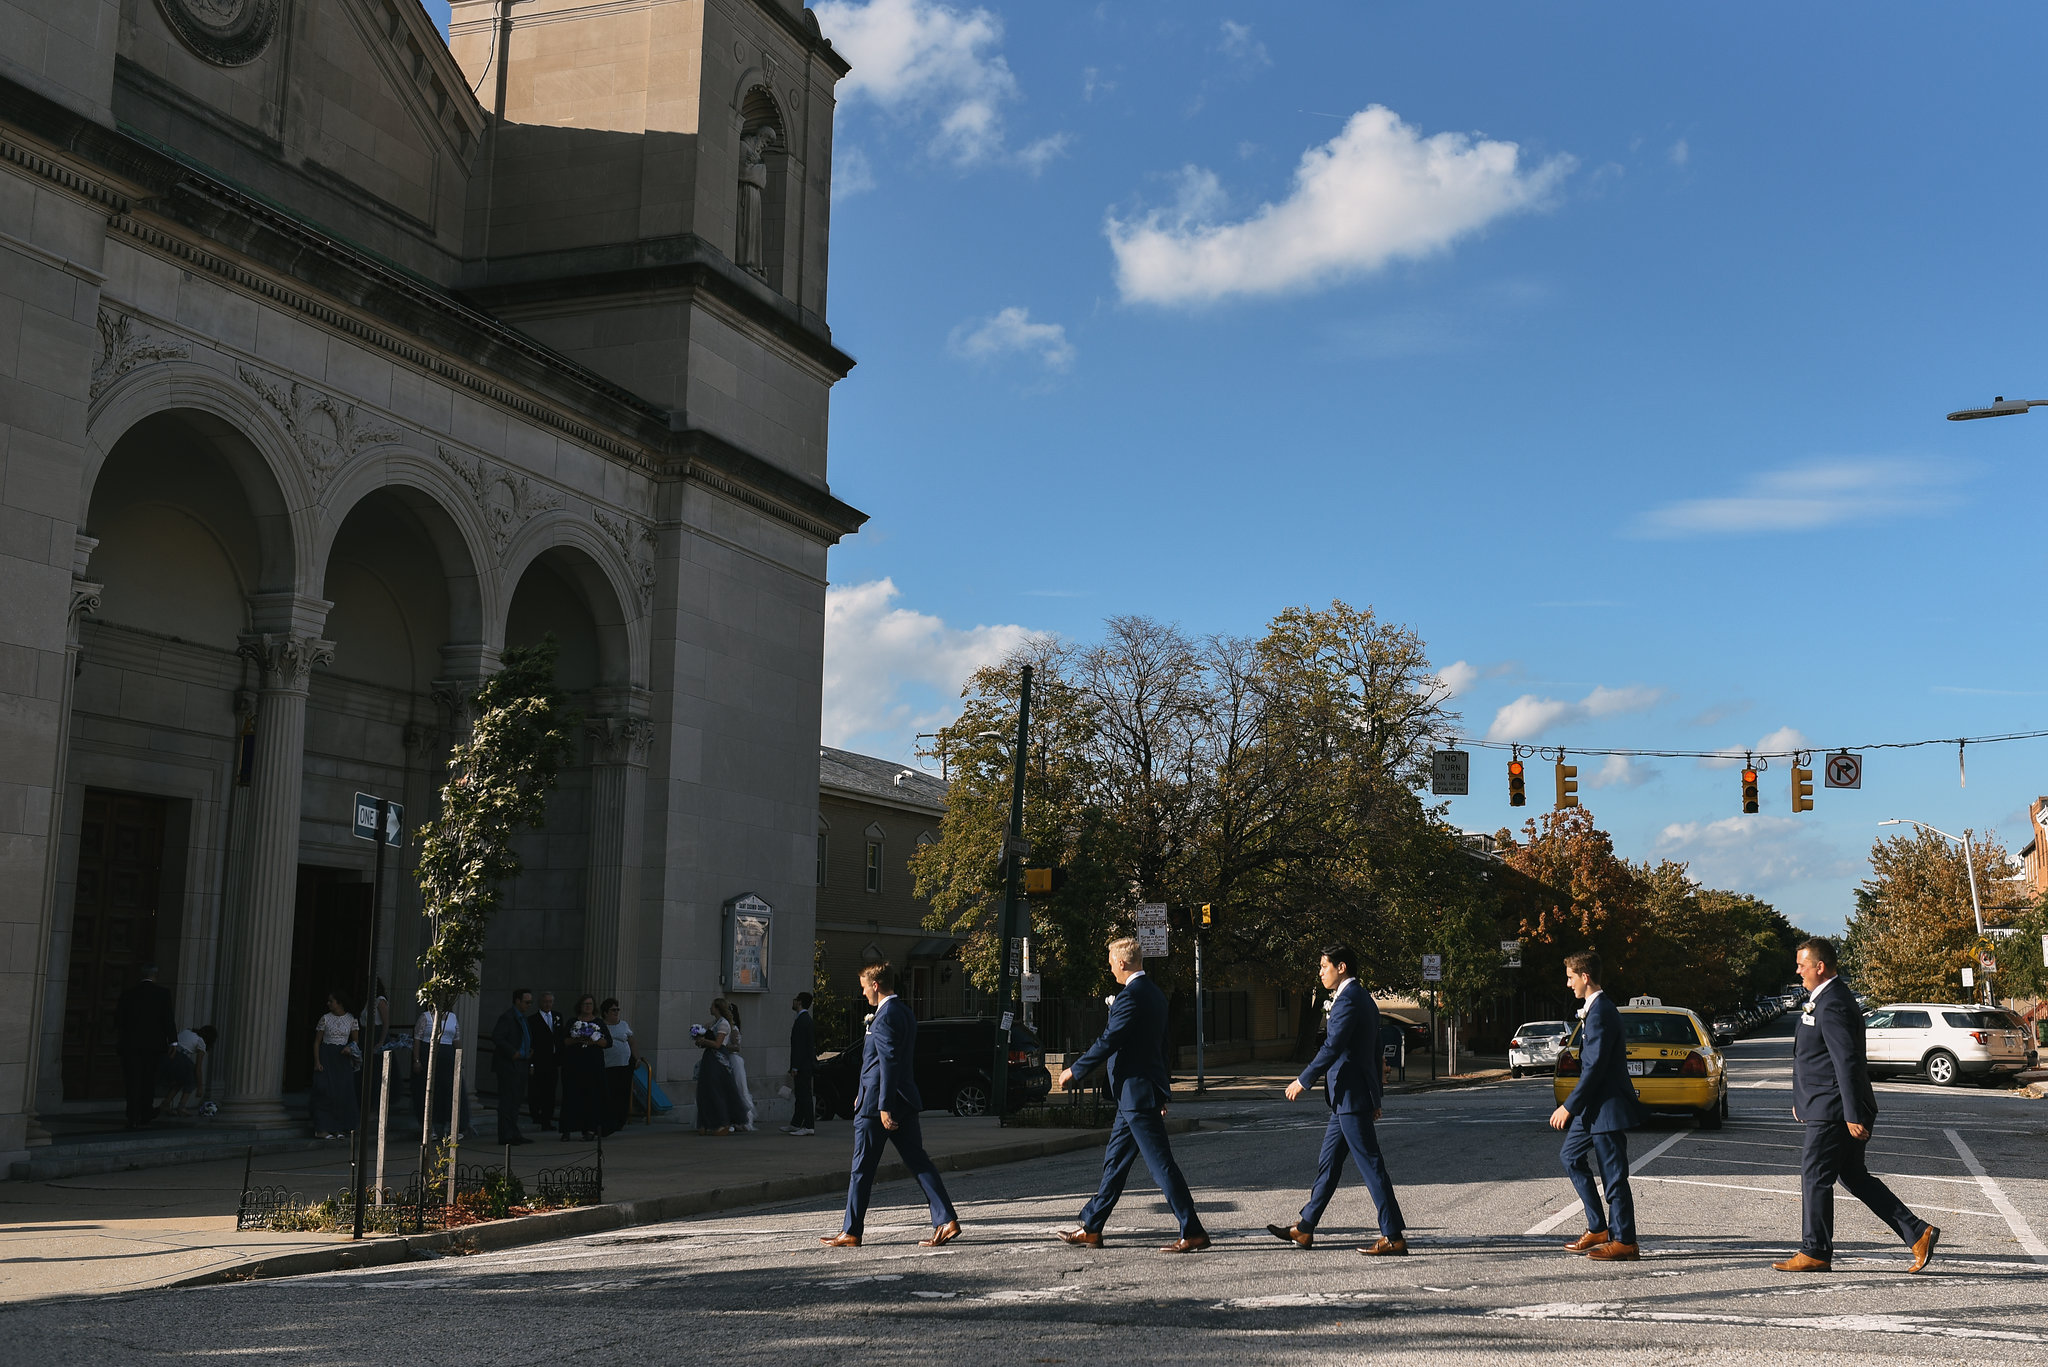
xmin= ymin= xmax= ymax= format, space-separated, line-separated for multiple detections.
xmin=219 ymin=627 xmax=334 ymax=1125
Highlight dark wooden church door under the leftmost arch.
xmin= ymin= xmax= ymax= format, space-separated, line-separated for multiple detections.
xmin=63 ymin=789 xmax=170 ymax=1101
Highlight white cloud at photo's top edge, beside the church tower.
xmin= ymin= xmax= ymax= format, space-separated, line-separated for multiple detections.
xmin=815 ymin=0 xmax=1065 ymax=170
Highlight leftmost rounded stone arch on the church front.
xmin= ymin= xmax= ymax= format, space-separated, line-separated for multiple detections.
xmin=78 ymin=361 xmax=317 ymax=596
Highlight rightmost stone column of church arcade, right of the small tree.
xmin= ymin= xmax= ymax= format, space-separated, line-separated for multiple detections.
xmin=584 ymin=715 xmax=653 ymax=1004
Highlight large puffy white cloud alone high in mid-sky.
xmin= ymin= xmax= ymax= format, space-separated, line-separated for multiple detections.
xmin=1106 ymin=105 xmax=1573 ymax=303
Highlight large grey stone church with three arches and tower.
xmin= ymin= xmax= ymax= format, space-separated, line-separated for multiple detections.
xmin=0 ymin=0 xmax=862 ymax=1160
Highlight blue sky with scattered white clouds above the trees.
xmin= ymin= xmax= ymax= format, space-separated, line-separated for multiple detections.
xmin=432 ymin=0 xmax=2048 ymax=930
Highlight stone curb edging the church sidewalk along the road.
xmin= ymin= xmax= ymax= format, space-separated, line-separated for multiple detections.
xmin=150 ymin=1119 xmax=1202 ymax=1289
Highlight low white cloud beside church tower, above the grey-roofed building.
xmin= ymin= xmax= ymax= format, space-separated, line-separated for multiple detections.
xmin=819 ymin=578 xmax=1036 ymax=758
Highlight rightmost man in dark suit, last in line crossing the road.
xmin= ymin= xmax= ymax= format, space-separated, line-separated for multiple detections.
xmin=1772 ymin=939 xmax=1942 ymax=1273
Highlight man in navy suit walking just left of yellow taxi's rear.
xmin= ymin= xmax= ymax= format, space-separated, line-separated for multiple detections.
xmin=1550 ymin=949 xmax=1642 ymax=1262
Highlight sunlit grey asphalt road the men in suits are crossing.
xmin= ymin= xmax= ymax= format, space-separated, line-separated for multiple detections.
xmin=16 ymin=1033 xmax=2048 ymax=1367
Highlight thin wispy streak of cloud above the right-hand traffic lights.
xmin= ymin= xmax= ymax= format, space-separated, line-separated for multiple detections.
xmin=1636 ymin=459 xmax=1956 ymax=537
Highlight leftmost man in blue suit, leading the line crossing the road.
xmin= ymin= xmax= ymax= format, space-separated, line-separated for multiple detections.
xmin=817 ymin=963 xmax=961 ymax=1248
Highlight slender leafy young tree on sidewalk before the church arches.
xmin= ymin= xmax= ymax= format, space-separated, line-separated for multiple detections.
xmin=420 ymin=635 xmax=578 ymax=1199
